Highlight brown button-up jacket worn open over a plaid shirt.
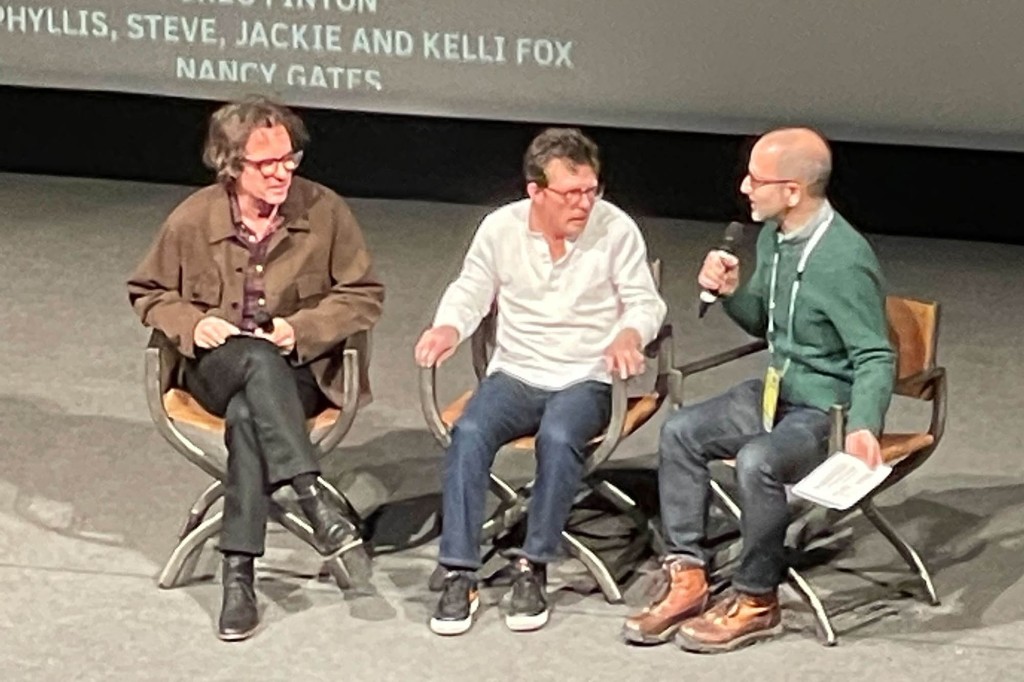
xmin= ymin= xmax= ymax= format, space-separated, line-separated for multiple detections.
xmin=128 ymin=177 xmax=384 ymax=404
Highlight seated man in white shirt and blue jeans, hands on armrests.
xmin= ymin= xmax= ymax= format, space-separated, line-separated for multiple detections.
xmin=415 ymin=128 xmax=666 ymax=635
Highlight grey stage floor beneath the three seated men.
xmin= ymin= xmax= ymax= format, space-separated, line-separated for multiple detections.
xmin=0 ymin=175 xmax=1024 ymax=681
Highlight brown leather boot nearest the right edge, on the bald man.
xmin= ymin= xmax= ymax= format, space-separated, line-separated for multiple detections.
xmin=676 ymin=592 xmax=782 ymax=653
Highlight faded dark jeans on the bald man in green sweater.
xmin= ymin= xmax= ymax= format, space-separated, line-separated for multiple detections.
xmin=657 ymin=380 xmax=828 ymax=594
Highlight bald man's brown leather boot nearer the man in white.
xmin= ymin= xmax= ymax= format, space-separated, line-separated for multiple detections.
xmin=623 ymin=559 xmax=708 ymax=644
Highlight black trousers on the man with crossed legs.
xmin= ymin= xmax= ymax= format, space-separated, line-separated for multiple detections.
xmin=184 ymin=337 xmax=327 ymax=556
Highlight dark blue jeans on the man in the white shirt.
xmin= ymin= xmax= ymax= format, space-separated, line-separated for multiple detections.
xmin=438 ymin=372 xmax=611 ymax=570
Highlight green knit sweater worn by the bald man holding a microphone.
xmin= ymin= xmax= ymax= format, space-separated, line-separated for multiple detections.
xmin=723 ymin=206 xmax=895 ymax=435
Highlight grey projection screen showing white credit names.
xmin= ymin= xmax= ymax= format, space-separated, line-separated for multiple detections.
xmin=0 ymin=0 xmax=1024 ymax=151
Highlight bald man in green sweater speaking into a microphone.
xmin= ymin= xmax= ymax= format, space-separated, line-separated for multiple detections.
xmin=624 ymin=128 xmax=895 ymax=652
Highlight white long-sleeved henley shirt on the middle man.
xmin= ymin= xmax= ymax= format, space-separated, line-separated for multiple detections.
xmin=434 ymin=199 xmax=666 ymax=390
